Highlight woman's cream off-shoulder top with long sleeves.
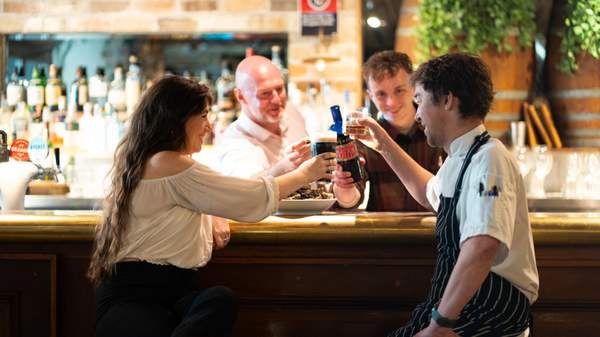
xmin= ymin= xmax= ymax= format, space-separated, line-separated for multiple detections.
xmin=117 ymin=163 xmax=279 ymax=268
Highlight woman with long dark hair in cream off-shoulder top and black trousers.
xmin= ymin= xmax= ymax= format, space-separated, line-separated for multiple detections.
xmin=88 ymin=76 xmax=335 ymax=337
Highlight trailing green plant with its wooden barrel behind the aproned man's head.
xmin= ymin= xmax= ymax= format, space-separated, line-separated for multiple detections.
xmin=417 ymin=0 xmax=535 ymax=139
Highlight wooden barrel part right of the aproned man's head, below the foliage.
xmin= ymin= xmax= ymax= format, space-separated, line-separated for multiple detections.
xmin=481 ymin=36 xmax=535 ymax=143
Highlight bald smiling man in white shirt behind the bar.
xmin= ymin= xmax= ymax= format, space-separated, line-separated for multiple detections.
xmin=200 ymin=55 xmax=311 ymax=178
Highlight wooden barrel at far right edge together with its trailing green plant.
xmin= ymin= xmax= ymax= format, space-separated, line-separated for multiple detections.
xmin=544 ymin=0 xmax=600 ymax=147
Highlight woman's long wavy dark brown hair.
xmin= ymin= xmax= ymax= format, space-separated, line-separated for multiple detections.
xmin=87 ymin=76 xmax=212 ymax=286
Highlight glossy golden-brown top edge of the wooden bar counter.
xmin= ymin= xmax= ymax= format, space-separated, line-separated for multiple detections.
xmin=0 ymin=211 xmax=600 ymax=245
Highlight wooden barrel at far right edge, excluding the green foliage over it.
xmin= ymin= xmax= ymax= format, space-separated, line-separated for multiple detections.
xmin=545 ymin=1 xmax=600 ymax=147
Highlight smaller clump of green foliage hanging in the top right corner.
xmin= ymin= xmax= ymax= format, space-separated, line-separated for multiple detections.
xmin=557 ymin=0 xmax=600 ymax=73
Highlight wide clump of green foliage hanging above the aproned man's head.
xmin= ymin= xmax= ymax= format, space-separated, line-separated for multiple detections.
xmin=417 ymin=0 xmax=536 ymax=59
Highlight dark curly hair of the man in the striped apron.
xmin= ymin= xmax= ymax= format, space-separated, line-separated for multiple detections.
xmin=410 ymin=53 xmax=494 ymax=119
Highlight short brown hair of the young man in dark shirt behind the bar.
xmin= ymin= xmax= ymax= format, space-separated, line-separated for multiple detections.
xmin=363 ymin=50 xmax=413 ymax=82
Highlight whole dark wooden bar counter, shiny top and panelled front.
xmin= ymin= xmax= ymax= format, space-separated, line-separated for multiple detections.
xmin=0 ymin=211 xmax=600 ymax=337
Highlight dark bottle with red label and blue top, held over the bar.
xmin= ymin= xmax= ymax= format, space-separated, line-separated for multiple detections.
xmin=330 ymin=105 xmax=363 ymax=182
